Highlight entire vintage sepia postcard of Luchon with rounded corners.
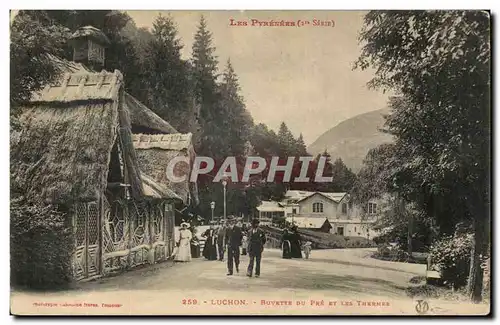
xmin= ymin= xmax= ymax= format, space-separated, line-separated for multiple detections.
xmin=10 ymin=10 xmax=491 ymax=316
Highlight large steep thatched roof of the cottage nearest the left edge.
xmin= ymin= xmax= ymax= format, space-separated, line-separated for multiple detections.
xmin=11 ymin=71 xmax=144 ymax=203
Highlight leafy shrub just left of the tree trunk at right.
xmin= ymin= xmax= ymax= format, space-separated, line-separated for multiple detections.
xmin=430 ymin=234 xmax=473 ymax=288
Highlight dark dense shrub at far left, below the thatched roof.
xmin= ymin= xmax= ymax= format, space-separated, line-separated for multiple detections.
xmin=10 ymin=199 xmax=74 ymax=289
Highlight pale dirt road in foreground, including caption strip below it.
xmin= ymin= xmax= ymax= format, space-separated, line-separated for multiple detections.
xmin=12 ymin=249 xmax=488 ymax=315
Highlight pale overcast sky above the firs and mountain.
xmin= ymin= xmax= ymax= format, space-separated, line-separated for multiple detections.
xmin=128 ymin=11 xmax=387 ymax=145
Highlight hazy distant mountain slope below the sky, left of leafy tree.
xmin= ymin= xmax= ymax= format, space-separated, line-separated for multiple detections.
xmin=307 ymin=109 xmax=392 ymax=172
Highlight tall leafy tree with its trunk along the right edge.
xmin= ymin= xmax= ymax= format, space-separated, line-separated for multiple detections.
xmin=357 ymin=11 xmax=491 ymax=302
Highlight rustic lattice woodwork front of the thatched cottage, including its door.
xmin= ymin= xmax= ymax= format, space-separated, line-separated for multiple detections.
xmin=72 ymin=198 xmax=174 ymax=280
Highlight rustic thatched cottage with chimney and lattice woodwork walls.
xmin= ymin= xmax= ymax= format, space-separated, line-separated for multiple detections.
xmin=11 ymin=28 xmax=196 ymax=279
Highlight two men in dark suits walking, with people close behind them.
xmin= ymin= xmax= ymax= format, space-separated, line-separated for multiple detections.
xmin=202 ymin=216 xmax=266 ymax=277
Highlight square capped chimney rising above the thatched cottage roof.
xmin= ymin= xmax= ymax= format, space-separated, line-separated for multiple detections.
xmin=70 ymin=26 xmax=110 ymax=71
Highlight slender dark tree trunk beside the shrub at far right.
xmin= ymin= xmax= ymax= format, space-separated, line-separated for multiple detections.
xmin=468 ymin=215 xmax=487 ymax=303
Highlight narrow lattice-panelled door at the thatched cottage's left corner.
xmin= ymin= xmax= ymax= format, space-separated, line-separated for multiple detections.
xmin=72 ymin=202 xmax=101 ymax=280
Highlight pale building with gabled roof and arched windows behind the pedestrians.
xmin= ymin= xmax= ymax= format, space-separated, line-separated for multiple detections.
xmin=282 ymin=191 xmax=378 ymax=238
